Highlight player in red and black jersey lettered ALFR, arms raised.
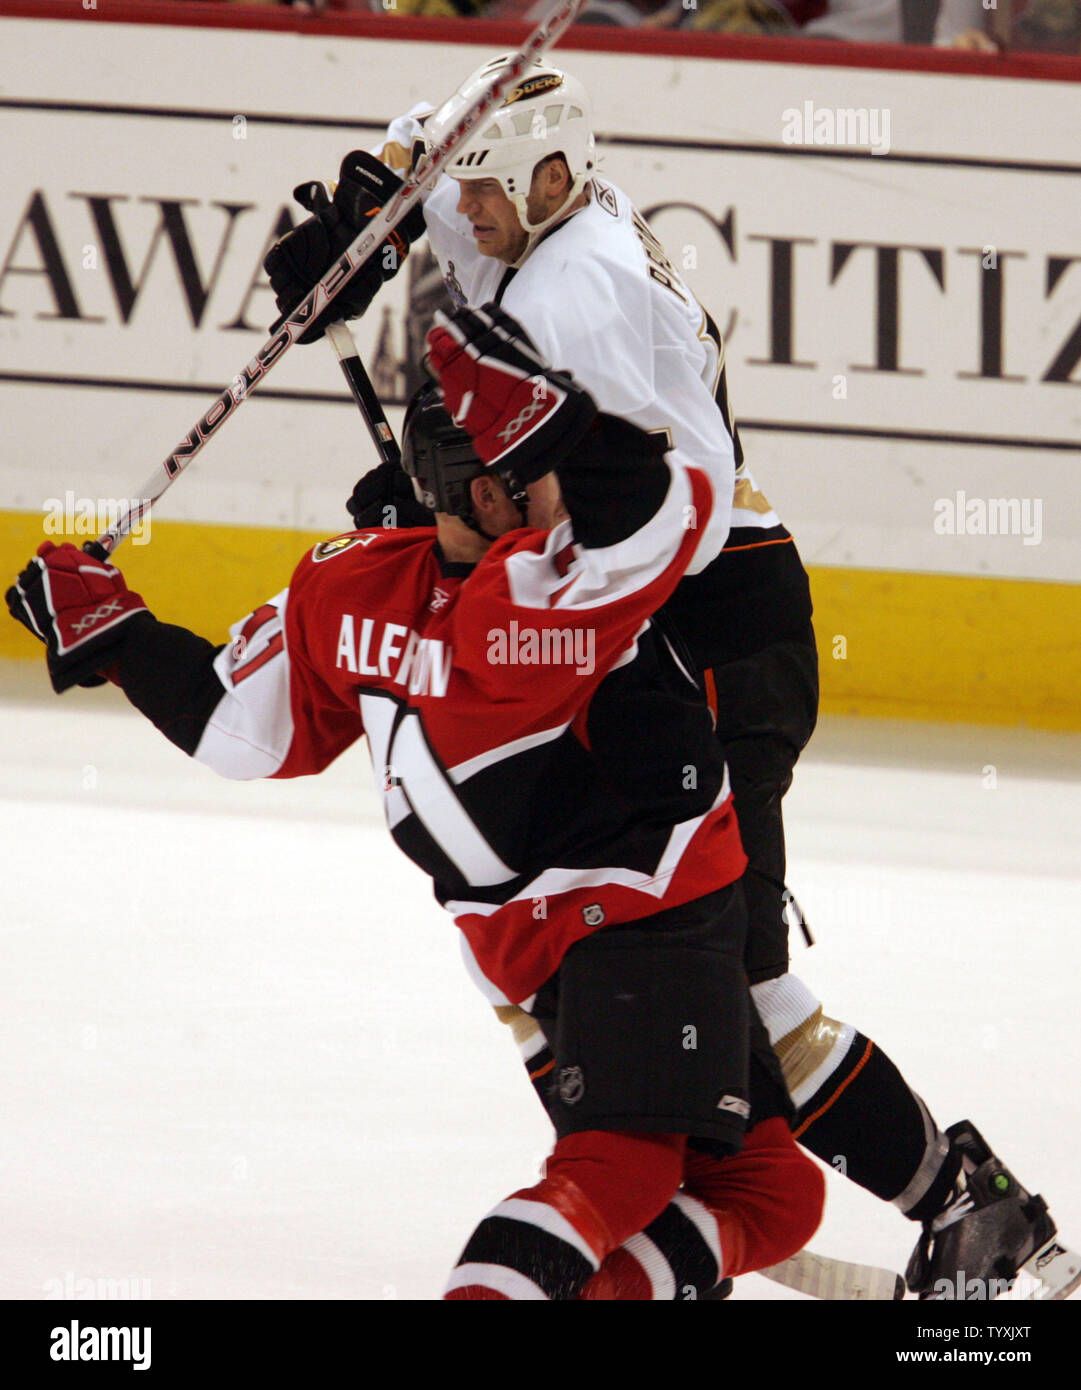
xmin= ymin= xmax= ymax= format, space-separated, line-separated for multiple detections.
xmin=8 ymin=311 xmax=823 ymax=1300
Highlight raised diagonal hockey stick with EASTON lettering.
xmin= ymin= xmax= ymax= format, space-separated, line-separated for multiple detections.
xmin=83 ymin=0 xmax=585 ymax=560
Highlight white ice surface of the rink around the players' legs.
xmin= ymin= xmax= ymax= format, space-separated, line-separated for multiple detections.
xmin=0 ymin=667 xmax=1081 ymax=1298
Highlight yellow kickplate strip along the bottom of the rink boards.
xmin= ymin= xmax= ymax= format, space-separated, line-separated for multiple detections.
xmin=0 ymin=512 xmax=1081 ymax=730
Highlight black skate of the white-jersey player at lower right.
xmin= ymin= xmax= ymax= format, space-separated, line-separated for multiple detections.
xmin=905 ymin=1120 xmax=1081 ymax=1300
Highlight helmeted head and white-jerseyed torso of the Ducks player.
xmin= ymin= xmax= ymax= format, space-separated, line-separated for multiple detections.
xmin=408 ymin=58 xmax=778 ymax=573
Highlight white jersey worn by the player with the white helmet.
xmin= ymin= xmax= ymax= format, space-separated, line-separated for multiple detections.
xmin=377 ymin=104 xmax=786 ymax=574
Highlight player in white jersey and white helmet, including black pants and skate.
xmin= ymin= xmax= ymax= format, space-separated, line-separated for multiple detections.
xmin=258 ymin=60 xmax=1053 ymax=1297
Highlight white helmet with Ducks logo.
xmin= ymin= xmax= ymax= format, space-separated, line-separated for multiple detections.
xmin=425 ymin=54 xmax=596 ymax=234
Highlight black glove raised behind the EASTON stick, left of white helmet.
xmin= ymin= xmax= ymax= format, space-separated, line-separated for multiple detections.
xmin=263 ymin=150 xmax=424 ymax=343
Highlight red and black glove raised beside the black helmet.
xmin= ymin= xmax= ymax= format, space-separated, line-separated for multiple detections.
xmin=428 ymin=304 xmax=597 ymax=484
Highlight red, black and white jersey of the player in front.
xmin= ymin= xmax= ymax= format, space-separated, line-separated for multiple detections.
xmin=113 ymin=423 xmax=745 ymax=1004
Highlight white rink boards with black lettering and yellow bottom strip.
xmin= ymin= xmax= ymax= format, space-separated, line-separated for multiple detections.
xmin=0 ymin=4 xmax=1081 ymax=728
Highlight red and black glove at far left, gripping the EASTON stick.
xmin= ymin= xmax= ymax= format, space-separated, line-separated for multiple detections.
xmin=6 ymin=541 xmax=147 ymax=695
